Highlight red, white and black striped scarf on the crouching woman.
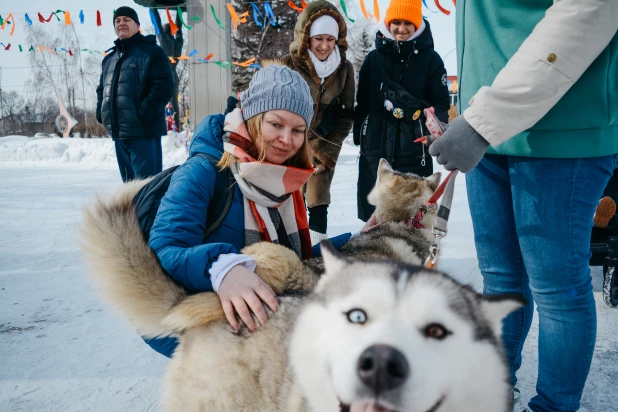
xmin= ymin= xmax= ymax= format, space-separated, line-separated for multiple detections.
xmin=223 ymin=109 xmax=313 ymax=259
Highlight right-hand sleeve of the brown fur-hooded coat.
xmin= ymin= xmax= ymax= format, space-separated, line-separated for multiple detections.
xmin=313 ymin=60 xmax=355 ymax=169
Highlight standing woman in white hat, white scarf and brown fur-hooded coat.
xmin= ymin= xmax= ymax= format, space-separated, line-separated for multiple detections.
xmin=283 ymin=0 xmax=355 ymax=243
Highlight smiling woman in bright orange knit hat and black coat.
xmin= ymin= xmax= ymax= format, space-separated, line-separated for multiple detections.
xmin=354 ymin=0 xmax=450 ymax=221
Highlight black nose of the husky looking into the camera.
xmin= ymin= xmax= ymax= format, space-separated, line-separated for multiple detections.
xmin=357 ymin=345 xmax=410 ymax=393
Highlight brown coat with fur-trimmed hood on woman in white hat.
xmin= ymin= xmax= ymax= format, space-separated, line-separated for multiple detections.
xmin=283 ymin=0 xmax=355 ymax=207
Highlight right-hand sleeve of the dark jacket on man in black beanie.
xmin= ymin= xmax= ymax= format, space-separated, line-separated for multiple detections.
xmin=139 ymin=46 xmax=174 ymax=120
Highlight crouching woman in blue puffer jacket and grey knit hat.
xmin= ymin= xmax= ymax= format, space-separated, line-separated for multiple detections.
xmin=147 ymin=65 xmax=350 ymax=356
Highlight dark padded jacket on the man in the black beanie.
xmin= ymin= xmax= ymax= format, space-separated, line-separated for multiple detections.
xmin=97 ymin=33 xmax=174 ymax=139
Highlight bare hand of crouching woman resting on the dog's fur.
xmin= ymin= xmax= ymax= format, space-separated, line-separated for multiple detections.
xmin=218 ymin=265 xmax=279 ymax=332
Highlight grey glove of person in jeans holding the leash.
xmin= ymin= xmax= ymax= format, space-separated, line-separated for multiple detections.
xmin=429 ymin=116 xmax=489 ymax=173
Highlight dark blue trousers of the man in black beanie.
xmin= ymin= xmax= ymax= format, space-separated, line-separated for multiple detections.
xmin=114 ymin=137 xmax=163 ymax=182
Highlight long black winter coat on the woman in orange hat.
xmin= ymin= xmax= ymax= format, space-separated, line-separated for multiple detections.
xmin=354 ymin=20 xmax=450 ymax=221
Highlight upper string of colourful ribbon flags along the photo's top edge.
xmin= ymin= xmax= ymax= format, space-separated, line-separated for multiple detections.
xmin=0 ymin=0 xmax=457 ymax=36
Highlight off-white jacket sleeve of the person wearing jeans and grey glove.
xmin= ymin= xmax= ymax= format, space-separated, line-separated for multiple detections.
xmin=463 ymin=0 xmax=618 ymax=146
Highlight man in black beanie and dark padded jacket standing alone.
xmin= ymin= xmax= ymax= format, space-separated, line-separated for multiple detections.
xmin=97 ymin=7 xmax=174 ymax=182
